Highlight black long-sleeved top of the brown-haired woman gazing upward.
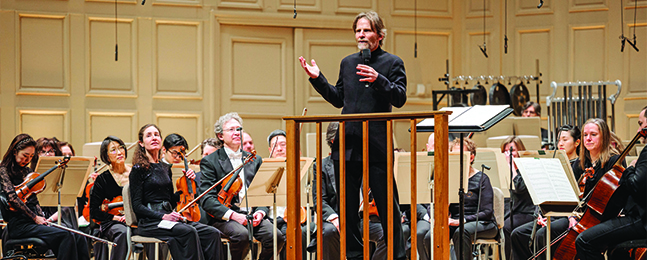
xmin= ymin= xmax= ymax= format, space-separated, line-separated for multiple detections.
xmin=129 ymin=163 xmax=178 ymax=220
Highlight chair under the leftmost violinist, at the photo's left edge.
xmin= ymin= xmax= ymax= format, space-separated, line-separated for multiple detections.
xmin=0 ymin=192 xmax=55 ymax=259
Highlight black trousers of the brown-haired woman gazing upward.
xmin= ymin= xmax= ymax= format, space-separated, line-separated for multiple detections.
xmin=139 ymin=220 xmax=224 ymax=260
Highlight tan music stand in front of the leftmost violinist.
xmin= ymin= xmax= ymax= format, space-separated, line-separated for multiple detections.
xmin=35 ymin=156 xmax=94 ymax=225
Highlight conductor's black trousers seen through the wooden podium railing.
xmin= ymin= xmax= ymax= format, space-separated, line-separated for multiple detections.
xmin=334 ymin=160 xmax=406 ymax=259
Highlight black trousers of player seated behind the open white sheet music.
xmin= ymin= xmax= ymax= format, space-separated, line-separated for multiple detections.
xmin=511 ymin=218 xmax=568 ymax=260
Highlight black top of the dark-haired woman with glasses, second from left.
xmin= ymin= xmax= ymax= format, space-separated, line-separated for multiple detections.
xmin=90 ymin=170 xmax=123 ymax=222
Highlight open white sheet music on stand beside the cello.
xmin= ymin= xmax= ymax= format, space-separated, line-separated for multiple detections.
xmin=514 ymin=158 xmax=578 ymax=205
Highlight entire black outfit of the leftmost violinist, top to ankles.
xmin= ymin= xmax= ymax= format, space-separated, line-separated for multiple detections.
xmin=0 ymin=166 xmax=90 ymax=260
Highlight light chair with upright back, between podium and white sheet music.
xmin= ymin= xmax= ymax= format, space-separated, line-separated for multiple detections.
xmin=474 ymin=187 xmax=505 ymax=260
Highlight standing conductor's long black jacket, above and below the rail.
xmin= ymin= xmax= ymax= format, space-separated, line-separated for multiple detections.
xmin=310 ymin=45 xmax=407 ymax=162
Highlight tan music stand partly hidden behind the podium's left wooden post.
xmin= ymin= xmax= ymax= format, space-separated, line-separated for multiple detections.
xmin=241 ymin=157 xmax=314 ymax=259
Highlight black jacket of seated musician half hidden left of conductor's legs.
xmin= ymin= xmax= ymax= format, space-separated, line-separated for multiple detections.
xmin=312 ymin=156 xmax=339 ymax=221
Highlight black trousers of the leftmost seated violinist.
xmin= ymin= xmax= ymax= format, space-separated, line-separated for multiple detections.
xmin=7 ymin=221 xmax=90 ymax=260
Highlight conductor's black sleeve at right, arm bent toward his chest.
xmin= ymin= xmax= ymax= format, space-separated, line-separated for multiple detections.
xmin=371 ymin=57 xmax=407 ymax=108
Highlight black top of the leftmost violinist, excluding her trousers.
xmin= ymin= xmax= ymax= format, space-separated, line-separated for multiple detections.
xmin=0 ymin=166 xmax=43 ymax=224
